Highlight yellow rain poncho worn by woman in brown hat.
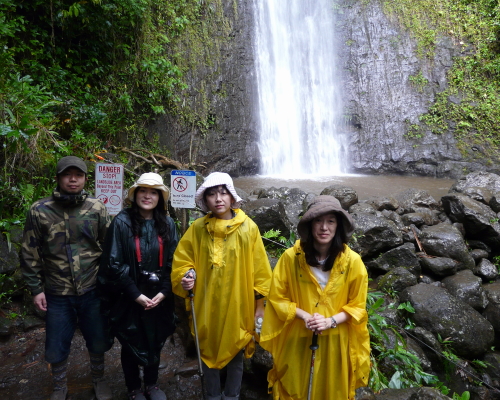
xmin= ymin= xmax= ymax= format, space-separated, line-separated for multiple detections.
xmin=260 ymin=241 xmax=370 ymax=400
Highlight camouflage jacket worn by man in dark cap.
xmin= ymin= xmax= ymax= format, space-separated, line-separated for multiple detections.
xmin=21 ymin=190 xmax=110 ymax=295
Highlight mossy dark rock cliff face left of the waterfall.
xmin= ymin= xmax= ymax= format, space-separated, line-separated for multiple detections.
xmin=150 ymin=0 xmax=260 ymax=176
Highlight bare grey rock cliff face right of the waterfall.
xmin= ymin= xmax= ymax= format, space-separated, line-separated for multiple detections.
xmin=340 ymin=0 xmax=482 ymax=177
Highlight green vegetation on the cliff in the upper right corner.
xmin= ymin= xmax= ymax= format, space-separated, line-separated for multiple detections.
xmin=383 ymin=0 xmax=500 ymax=159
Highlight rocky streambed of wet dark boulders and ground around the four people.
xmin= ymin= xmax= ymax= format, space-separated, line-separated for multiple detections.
xmin=0 ymin=172 xmax=500 ymax=400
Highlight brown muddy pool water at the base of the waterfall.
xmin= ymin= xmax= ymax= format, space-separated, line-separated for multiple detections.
xmin=234 ymin=175 xmax=455 ymax=201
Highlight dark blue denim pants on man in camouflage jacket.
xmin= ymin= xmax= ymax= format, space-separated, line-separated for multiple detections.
xmin=45 ymin=289 xmax=108 ymax=364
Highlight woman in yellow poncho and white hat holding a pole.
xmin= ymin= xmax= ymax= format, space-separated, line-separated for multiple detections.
xmin=172 ymin=172 xmax=271 ymax=400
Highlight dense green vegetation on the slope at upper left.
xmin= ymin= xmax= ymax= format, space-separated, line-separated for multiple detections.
xmin=0 ymin=0 xmax=229 ymax=228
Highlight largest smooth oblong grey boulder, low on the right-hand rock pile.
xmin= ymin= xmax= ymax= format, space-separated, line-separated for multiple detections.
xmin=399 ymin=284 xmax=494 ymax=359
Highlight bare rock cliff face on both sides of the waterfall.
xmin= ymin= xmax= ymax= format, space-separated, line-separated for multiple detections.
xmin=150 ymin=0 xmax=494 ymax=177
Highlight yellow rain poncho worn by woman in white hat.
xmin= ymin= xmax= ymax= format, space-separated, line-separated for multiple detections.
xmin=172 ymin=209 xmax=271 ymax=369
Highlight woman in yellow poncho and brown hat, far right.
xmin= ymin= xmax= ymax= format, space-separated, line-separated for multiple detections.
xmin=260 ymin=196 xmax=370 ymax=400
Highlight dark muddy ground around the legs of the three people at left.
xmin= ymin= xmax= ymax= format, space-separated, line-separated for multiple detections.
xmin=0 ymin=302 xmax=270 ymax=400
